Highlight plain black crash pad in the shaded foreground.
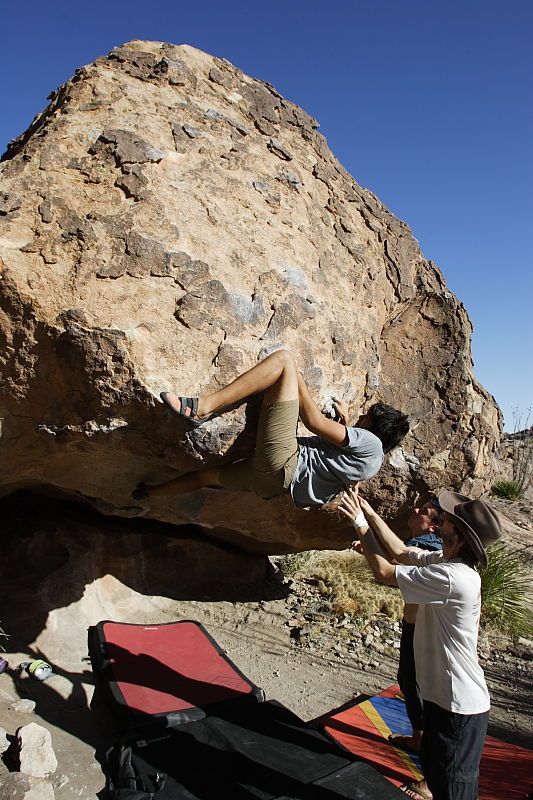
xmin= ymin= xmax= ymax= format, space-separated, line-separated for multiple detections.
xmin=105 ymin=702 xmax=404 ymax=800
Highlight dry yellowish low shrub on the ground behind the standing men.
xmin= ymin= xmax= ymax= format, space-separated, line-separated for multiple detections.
xmin=312 ymin=553 xmax=403 ymax=621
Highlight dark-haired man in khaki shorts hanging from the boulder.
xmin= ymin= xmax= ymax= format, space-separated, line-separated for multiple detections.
xmin=133 ymin=350 xmax=409 ymax=508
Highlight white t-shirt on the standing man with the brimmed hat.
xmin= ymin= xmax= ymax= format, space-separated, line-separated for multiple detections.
xmin=396 ymin=547 xmax=490 ymax=714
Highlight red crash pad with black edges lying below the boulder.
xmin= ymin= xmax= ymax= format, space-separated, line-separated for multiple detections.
xmin=89 ymin=620 xmax=264 ymax=725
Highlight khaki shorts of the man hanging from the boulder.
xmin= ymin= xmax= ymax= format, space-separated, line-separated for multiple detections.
xmin=220 ymin=399 xmax=299 ymax=500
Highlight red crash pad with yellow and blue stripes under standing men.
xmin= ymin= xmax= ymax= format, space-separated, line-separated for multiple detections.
xmin=321 ymin=686 xmax=533 ymax=800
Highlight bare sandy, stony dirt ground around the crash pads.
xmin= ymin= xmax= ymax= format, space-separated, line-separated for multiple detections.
xmin=0 ymin=490 xmax=533 ymax=800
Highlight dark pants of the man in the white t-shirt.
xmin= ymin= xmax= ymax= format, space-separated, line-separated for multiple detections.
xmin=420 ymin=700 xmax=489 ymax=800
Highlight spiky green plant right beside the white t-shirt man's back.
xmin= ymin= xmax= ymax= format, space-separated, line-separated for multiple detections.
xmin=480 ymin=542 xmax=533 ymax=636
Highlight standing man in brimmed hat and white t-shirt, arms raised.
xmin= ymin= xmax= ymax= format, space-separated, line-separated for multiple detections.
xmin=341 ymin=488 xmax=501 ymax=800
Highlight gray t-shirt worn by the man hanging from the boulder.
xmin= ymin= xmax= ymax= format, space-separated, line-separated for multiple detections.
xmin=291 ymin=428 xmax=383 ymax=508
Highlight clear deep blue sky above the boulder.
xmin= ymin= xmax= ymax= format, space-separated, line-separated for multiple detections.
xmin=0 ymin=0 xmax=533 ymax=430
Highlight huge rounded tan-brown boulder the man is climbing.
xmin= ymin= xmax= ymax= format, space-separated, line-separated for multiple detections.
xmin=0 ymin=41 xmax=500 ymax=553
